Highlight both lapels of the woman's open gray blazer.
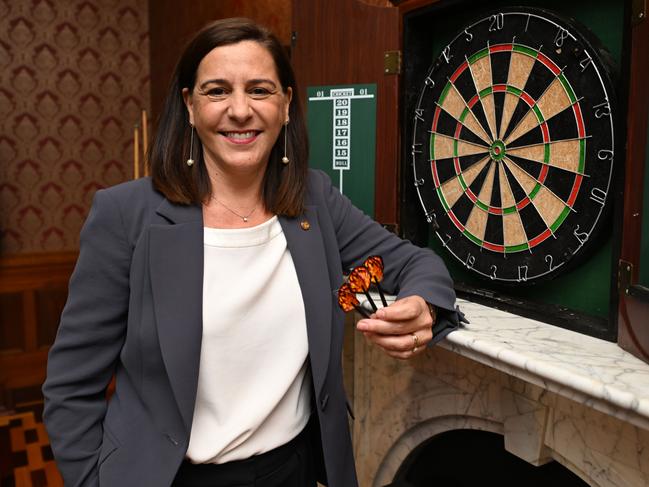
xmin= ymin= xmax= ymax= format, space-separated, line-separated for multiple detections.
xmin=149 ymin=200 xmax=332 ymax=431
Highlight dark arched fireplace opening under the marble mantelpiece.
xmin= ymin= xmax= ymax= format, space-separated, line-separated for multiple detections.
xmin=386 ymin=430 xmax=588 ymax=487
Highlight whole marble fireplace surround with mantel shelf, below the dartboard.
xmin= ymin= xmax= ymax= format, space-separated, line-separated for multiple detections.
xmin=344 ymin=296 xmax=649 ymax=487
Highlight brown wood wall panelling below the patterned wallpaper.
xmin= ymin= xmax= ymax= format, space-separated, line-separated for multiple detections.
xmin=0 ymin=252 xmax=77 ymax=410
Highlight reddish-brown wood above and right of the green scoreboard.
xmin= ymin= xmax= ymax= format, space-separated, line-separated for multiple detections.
xmin=291 ymin=0 xmax=400 ymax=225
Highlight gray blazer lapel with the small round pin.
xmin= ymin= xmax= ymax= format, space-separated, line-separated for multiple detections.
xmin=279 ymin=206 xmax=332 ymax=397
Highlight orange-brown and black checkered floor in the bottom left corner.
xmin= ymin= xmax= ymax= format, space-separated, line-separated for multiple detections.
xmin=0 ymin=406 xmax=63 ymax=487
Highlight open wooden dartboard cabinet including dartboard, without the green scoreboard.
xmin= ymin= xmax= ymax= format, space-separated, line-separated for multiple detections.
xmin=291 ymin=0 xmax=649 ymax=361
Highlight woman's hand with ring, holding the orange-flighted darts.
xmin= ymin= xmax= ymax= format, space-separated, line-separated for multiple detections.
xmin=356 ymin=296 xmax=433 ymax=360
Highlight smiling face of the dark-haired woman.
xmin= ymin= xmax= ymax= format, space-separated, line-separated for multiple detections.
xmin=183 ymin=41 xmax=292 ymax=174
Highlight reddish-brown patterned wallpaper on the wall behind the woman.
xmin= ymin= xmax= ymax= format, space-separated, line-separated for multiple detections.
xmin=0 ymin=0 xmax=149 ymax=256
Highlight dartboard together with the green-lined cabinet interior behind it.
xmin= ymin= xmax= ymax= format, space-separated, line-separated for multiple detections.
xmin=401 ymin=2 xmax=625 ymax=339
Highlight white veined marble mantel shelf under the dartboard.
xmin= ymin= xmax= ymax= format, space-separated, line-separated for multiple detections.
xmin=440 ymin=300 xmax=649 ymax=429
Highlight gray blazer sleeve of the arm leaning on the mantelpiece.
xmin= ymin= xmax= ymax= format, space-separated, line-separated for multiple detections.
xmin=314 ymin=171 xmax=464 ymax=332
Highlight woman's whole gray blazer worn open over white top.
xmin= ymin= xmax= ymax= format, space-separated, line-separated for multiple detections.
xmin=43 ymin=171 xmax=458 ymax=487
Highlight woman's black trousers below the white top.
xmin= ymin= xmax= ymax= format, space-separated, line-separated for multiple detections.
xmin=172 ymin=418 xmax=316 ymax=487
